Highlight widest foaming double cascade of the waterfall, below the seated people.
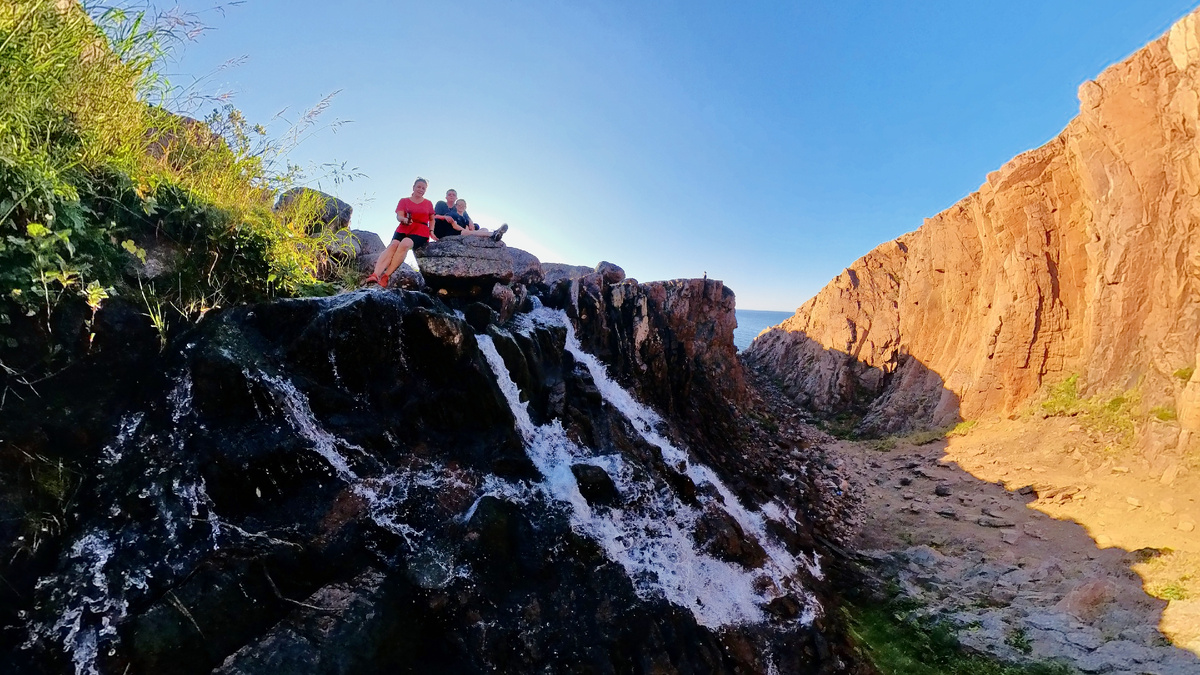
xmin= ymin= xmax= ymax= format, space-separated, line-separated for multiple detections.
xmin=476 ymin=309 xmax=820 ymax=628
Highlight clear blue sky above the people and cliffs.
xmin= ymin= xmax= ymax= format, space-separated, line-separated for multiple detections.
xmin=160 ymin=0 xmax=1196 ymax=311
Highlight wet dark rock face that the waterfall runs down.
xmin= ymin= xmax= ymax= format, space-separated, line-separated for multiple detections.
xmin=0 ymin=275 xmax=857 ymax=675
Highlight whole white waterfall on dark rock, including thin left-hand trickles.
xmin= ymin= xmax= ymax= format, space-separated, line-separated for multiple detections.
xmin=42 ymin=309 xmax=821 ymax=675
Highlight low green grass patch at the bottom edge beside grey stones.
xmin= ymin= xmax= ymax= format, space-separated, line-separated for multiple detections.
xmin=846 ymin=604 xmax=1073 ymax=675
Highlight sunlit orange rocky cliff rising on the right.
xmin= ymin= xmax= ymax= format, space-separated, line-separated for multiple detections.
xmin=748 ymin=7 xmax=1200 ymax=431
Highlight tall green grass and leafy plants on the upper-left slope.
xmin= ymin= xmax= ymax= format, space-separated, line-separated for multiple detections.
xmin=0 ymin=0 xmax=355 ymax=375
